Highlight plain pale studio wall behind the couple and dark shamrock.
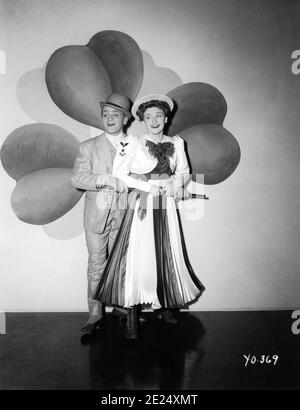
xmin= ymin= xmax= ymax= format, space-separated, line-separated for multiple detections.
xmin=0 ymin=0 xmax=300 ymax=311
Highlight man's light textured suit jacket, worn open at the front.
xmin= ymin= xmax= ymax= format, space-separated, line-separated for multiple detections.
xmin=71 ymin=133 xmax=135 ymax=233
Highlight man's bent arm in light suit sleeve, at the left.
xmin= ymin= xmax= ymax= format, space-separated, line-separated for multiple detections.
xmin=71 ymin=143 xmax=122 ymax=191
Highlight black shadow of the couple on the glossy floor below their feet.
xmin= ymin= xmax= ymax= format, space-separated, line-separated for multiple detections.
xmin=83 ymin=314 xmax=205 ymax=389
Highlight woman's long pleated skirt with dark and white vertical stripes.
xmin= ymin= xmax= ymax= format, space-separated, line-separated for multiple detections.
xmin=94 ymin=191 xmax=205 ymax=309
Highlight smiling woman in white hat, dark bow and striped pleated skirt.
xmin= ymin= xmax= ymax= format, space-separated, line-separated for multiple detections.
xmin=94 ymin=94 xmax=204 ymax=339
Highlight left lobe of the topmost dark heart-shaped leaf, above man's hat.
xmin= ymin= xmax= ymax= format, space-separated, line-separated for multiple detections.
xmin=46 ymin=46 xmax=112 ymax=128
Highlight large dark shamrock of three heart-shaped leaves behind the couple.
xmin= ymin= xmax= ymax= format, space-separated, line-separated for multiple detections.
xmin=1 ymin=30 xmax=240 ymax=225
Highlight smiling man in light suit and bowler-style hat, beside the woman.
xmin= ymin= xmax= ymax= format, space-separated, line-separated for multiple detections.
xmin=71 ymin=93 xmax=136 ymax=333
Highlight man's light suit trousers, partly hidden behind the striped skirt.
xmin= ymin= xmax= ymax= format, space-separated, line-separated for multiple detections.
xmin=85 ymin=210 xmax=122 ymax=316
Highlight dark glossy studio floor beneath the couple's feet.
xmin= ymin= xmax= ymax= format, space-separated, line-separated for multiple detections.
xmin=0 ymin=311 xmax=300 ymax=390
